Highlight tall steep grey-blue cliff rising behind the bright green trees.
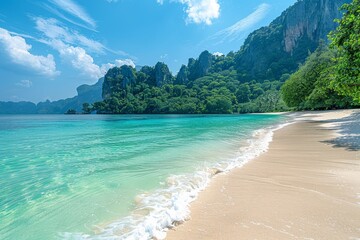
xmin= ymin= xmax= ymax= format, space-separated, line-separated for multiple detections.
xmin=236 ymin=0 xmax=350 ymax=80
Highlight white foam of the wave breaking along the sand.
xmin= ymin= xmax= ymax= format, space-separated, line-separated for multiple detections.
xmin=60 ymin=123 xmax=291 ymax=240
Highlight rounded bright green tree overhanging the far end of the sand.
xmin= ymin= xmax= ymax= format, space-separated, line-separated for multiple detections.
xmin=281 ymin=45 xmax=356 ymax=110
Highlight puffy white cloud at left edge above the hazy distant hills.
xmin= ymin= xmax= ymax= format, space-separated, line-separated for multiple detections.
xmin=0 ymin=28 xmax=59 ymax=76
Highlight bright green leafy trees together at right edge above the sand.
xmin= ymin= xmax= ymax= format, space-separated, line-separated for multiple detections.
xmin=282 ymin=0 xmax=360 ymax=110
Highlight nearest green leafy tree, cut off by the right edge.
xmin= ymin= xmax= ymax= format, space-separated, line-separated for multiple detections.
xmin=329 ymin=0 xmax=360 ymax=103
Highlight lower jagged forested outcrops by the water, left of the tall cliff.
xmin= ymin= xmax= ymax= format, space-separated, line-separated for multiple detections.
xmin=93 ymin=51 xmax=285 ymax=114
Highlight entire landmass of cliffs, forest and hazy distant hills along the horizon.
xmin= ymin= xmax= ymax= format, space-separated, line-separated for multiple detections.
xmin=0 ymin=0 xmax=360 ymax=114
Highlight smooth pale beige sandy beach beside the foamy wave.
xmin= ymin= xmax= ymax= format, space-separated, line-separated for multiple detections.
xmin=167 ymin=111 xmax=360 ymax=240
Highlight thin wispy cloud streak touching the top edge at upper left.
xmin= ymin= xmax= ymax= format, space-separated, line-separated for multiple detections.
xmin=51 ymin=0 xmax=96 ymax=28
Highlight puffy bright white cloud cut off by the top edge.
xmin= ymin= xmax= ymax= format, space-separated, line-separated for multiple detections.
xmin=157 ymin=0 xmax=220 ymax=25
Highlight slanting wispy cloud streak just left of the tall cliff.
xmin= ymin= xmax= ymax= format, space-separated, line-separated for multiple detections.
xmin=213 ymin=3 xmax=270 ymax=41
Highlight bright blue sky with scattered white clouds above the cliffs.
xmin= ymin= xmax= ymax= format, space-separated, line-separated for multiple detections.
xmin=0 ymin=0 xmax=296 ymax=103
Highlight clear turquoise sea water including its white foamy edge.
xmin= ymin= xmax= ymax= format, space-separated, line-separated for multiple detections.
xmin=0 ymin=115 xmax=284 ymax=240
